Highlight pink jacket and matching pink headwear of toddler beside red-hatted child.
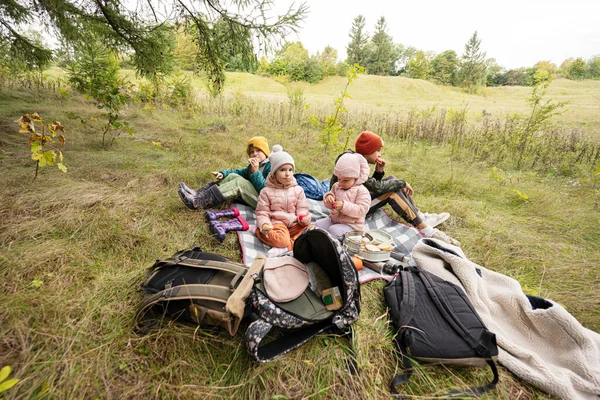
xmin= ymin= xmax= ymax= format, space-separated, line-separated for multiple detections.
xmin=323 ymin=153 xmax=371 ymax=231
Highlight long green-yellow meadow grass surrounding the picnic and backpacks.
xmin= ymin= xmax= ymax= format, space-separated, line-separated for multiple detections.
xmin=0 ymin=82 xmax=600 ymax=399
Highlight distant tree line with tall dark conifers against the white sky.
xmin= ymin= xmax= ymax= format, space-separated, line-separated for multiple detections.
xmin=239 ymin=15 xmax=600 ymax=92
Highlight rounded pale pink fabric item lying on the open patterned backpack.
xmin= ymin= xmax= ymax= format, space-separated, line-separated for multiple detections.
xmin=263 ymin=256 xmax=308 ymax=303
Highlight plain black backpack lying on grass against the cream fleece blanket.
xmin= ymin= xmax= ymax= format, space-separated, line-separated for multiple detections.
xmin=383 ymin=267 xmax=498 ymax=396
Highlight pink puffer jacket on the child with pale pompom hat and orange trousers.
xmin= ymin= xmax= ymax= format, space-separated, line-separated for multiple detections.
xmin=256 ymin=175 xmax=310 ymax=229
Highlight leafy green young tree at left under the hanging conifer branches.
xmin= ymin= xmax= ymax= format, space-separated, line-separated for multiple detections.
xmin=68 ymin=39 xmax=134 ymax=148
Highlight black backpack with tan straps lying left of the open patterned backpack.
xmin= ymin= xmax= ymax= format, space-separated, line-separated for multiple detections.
xmin=135 ymin=247 xmax=254 ymax=336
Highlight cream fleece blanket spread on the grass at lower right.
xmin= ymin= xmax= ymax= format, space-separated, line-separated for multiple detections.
xmin=412 ymin=239 xmax=600 ymax=400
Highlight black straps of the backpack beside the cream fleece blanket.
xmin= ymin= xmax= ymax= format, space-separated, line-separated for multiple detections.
xmin=392 ymin=268 xmax=498 ymax=396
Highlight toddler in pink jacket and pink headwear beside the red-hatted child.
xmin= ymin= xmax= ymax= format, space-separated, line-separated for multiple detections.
xmin=316 ymin=153 xmax=371 ymax=240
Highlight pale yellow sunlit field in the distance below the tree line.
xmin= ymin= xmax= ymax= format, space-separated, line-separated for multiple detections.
xmin=48 ymin=68 xmax=600 ymax=134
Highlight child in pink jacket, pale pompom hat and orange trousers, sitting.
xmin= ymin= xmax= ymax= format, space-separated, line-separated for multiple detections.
xmin=256 ymin=145 xmax=310 ymax=256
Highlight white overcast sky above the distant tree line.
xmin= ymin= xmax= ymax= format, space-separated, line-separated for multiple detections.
xmin=275 ymin=0 xmax=600 ymax=68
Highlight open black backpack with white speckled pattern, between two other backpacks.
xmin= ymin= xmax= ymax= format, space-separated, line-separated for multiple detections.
xmin=245 ymin=228 xmax=360 ymax=362
